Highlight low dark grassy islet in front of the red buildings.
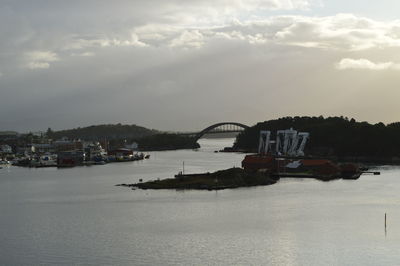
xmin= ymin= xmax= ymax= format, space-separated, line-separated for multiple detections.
xmin=117 ymin=168 xmax=277 ymax=190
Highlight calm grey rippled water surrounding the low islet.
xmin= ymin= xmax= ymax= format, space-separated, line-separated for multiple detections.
xmin=0 ymin=139 xmax=400 ymax=265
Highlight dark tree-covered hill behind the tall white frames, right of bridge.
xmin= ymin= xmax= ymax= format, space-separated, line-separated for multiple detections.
xmin=234 ymin=116 xmax=400 ymax=157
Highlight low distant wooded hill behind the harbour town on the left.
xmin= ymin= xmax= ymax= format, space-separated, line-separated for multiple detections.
xmin=47 ymin=124 xmax=159 ymax=140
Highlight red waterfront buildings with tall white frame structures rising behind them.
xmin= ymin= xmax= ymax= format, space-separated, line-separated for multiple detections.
xmin=242 ymin=128 xmax=361 ymax=180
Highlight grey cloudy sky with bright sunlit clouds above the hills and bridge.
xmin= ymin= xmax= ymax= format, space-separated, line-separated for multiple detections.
xmin=0 ymin=0 xmax=400 ymax=131
